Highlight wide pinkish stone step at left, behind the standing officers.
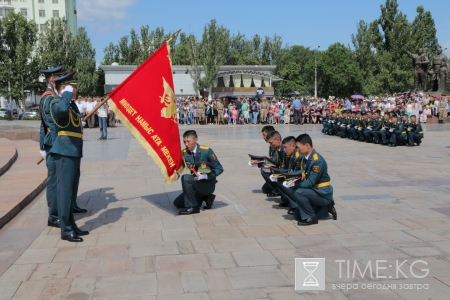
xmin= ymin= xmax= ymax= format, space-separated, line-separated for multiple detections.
xmin=0 ymin=140 xmax=47 ymax=228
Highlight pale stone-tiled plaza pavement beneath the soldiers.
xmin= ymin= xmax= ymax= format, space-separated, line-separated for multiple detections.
xmin=0 ymin=120 xmax=450 ymax=300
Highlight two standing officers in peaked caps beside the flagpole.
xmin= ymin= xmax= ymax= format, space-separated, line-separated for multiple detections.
xmin=39 ymin=66 xmax=89 ymax=242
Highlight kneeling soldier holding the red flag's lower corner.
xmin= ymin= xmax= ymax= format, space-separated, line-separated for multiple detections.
xmin=173 ymin=130 xmax=223 ymax=215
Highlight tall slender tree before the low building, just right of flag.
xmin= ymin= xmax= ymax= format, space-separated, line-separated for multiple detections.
xmin=201 ymin=19 xmax=230 ymax=96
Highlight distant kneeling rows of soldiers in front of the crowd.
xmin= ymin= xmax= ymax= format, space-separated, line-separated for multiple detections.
xmin=322 ymin=110 xmax=424 ymax=147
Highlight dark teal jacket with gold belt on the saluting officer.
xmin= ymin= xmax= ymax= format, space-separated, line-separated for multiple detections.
xmin=50 ymin=92 xmax=83 ymax=157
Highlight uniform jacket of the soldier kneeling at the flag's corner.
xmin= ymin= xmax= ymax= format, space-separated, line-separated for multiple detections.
xmin=182 ymin=144 xmax=223 ymax=183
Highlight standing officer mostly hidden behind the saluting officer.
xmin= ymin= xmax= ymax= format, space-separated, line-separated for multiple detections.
xmin=39 ymin=66 xmax=64 ymax=228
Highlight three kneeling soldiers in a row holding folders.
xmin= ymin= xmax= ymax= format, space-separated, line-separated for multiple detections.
xmin=249 ymin=125 xmax=337 ymax=226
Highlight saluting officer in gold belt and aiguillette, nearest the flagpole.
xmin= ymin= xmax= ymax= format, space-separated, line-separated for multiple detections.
xmin=49 ymin=72 xmax=89 ymax=242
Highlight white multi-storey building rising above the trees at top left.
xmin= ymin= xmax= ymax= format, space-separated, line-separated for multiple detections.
xmin=0 ymin=0 xmax=78 ymax=34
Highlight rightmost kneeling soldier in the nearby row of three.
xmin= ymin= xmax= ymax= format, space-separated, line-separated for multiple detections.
xmin=283 ymin=134 xmax=337 ymax=226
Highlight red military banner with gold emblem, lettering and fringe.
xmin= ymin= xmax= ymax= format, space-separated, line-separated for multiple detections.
xmin=108 ymin=42 xmax=183 ymax=183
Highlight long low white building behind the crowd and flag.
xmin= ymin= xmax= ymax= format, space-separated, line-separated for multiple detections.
xmin=100 ymin=64 xmax=282 ymax=97
